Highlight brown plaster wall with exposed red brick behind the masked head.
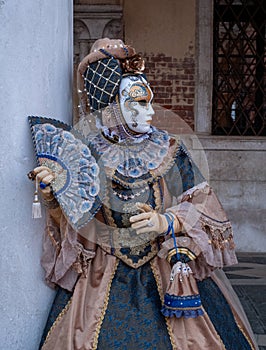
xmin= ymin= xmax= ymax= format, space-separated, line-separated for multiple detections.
xmin=124 ymin=0 xmax=196 ymax=132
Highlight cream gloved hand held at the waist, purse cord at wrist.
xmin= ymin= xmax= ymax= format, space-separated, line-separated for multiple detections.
xmin=130 ymin=203 xmax=179 ymax=235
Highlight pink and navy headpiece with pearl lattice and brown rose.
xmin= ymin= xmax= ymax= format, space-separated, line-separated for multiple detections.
xmin=78 ymin=38 xmax=145 ymax=112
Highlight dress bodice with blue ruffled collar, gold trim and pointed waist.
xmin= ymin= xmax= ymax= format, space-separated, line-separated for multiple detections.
xmin=87 ymin=131 xmax=202 ymax=268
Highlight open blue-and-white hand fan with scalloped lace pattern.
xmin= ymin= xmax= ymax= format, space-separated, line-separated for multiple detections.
xmin=29 ymin=116 xmax=101 ymax=230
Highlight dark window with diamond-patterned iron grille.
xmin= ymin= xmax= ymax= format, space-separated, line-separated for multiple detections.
xmin=212 ymin=0 xmax=266 ymax=136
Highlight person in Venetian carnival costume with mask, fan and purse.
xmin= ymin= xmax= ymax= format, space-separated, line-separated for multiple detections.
xmin=30 ymin=38 xmax=257 ymax=350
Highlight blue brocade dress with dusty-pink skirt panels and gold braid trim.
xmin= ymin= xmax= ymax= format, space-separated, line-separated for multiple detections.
xmin=40 ymin=131 xmax=256 ymax=350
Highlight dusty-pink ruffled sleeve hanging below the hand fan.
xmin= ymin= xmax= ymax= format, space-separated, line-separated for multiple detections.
xmin=41 ymin=211 xmax=95 ymax=291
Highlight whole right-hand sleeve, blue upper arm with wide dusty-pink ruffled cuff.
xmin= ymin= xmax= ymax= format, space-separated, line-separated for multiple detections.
xmin=165 ymin=141 xmax=237 ymax=279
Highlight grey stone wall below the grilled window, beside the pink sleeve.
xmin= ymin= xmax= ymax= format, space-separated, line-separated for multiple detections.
xmin=200 ymin=136 xmax=266 ymax=252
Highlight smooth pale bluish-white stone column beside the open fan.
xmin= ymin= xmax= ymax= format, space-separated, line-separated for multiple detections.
xmin=0 ymin=0 xmax=73 ymax=350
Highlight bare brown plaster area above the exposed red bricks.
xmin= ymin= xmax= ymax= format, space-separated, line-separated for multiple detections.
xmin=124 ymin=0 xmax=196 ymax=58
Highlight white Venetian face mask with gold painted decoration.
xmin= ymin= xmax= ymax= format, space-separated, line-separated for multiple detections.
xmin=119 ymin=75 xmax=154 ymax=134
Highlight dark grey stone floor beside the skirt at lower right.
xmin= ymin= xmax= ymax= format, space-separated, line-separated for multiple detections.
xmin=224 ymin=253 xmax=266 ymax=350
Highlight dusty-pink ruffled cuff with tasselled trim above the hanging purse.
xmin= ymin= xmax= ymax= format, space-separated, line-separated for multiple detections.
xmin=168 ymin=182 xmax=237 ymax=279
